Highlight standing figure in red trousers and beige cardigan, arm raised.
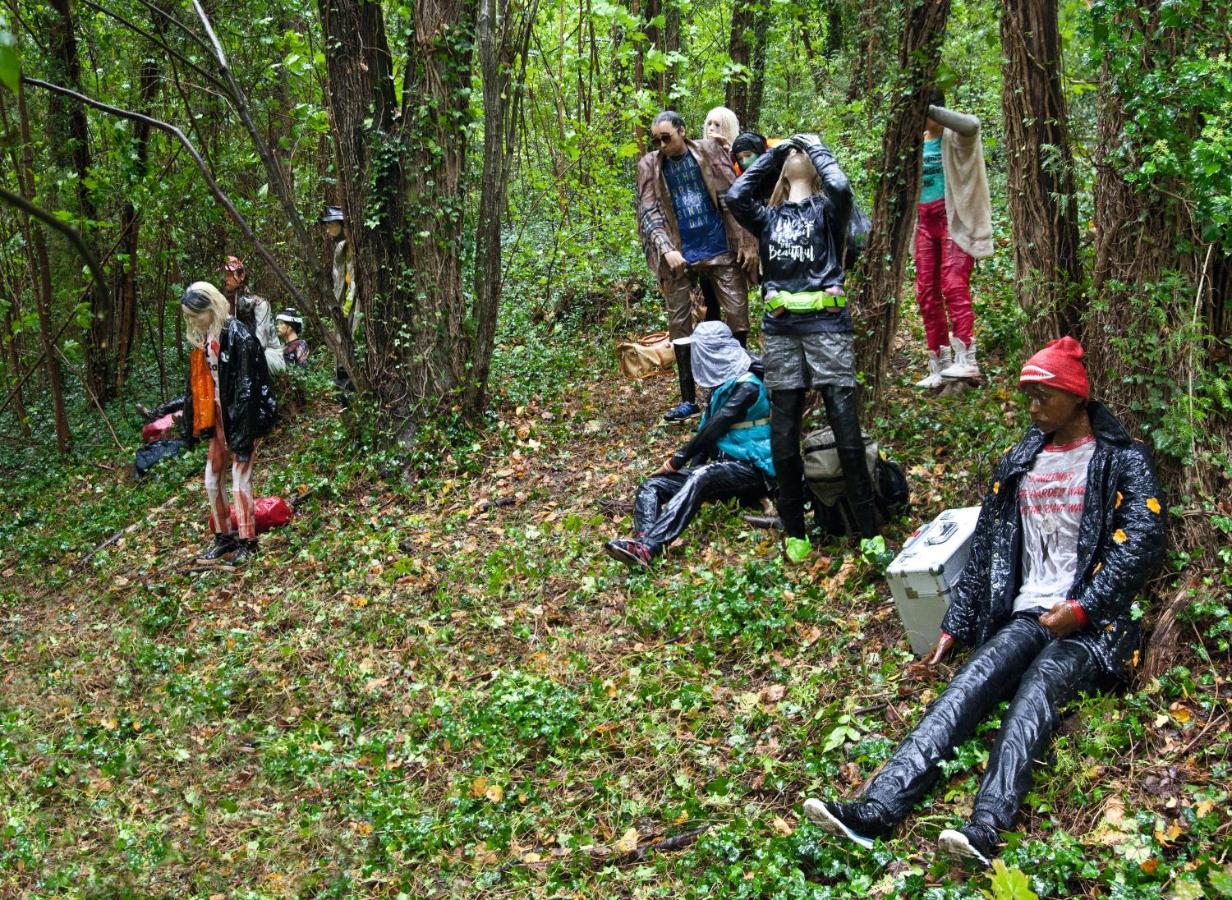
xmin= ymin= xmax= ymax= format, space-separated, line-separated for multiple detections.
xmin=913 ymin=91 xmax=993 ymax=388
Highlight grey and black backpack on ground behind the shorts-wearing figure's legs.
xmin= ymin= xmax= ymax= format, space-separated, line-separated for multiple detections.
xmin=804 ymin=426 xmax=910 ymax=536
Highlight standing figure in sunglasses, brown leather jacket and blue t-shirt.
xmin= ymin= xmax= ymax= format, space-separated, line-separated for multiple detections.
xmin=637 ymin=110 xmax=758 ymax=422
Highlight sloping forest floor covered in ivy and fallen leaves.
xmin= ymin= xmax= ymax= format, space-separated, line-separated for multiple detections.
xmin=0 ymin=299 xmax=1232 ymax=898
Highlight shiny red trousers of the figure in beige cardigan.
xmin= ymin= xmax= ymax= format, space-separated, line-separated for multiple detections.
xmin=915 ymin=197 xmax=976 ymax=353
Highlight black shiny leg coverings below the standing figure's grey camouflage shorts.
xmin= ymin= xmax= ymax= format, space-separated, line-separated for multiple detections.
xmin=770 ymin=384 xmax=878 ymax=538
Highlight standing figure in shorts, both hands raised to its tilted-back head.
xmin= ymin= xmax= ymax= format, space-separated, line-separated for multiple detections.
xmin=727 ymin=134 xmax=878 ymax=561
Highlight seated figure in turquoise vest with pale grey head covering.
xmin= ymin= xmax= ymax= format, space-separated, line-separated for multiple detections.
xmin=604 ymin=321 xmax=774 ymax=569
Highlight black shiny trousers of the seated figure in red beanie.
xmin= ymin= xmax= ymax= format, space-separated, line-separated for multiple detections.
xmin=864 ymin=613 xmax=1099 ymax=831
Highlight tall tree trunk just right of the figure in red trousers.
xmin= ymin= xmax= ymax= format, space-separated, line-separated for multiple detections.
xmin=1000 ymin=0 xmax=1084 ymax=347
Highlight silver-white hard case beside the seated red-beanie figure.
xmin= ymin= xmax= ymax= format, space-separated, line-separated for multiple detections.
xmin=886 ymin=506 xmax=979 ymax=656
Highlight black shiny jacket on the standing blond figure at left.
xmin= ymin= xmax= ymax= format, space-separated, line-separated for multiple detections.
xmin=181 ymin=316 xmax=278 ymax=457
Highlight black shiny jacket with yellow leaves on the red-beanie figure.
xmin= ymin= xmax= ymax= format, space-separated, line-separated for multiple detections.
xmin=941 ymin=401 xmax=1164 ymax=677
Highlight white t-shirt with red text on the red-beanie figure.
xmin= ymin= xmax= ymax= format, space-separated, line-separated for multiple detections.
xmin=1014 ymin=435 xmax=1095 ymax=620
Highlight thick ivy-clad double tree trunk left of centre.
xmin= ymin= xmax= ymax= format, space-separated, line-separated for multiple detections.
xmin=319 ymin=0 xmax=478 ymax=442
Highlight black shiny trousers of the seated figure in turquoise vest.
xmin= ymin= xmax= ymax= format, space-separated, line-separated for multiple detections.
xmin=633 ymin=459 xmax=766 ymax=554
